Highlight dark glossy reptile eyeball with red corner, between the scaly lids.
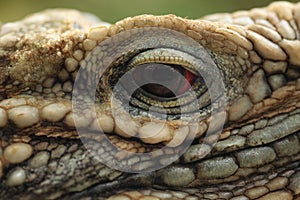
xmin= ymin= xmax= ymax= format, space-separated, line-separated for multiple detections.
xmin=133 ymin=63 xmax=195 ymax=98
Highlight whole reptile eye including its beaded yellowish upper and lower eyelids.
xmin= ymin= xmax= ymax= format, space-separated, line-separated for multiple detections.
xmin=109 ymin=48 xmax=210 ymax=118
